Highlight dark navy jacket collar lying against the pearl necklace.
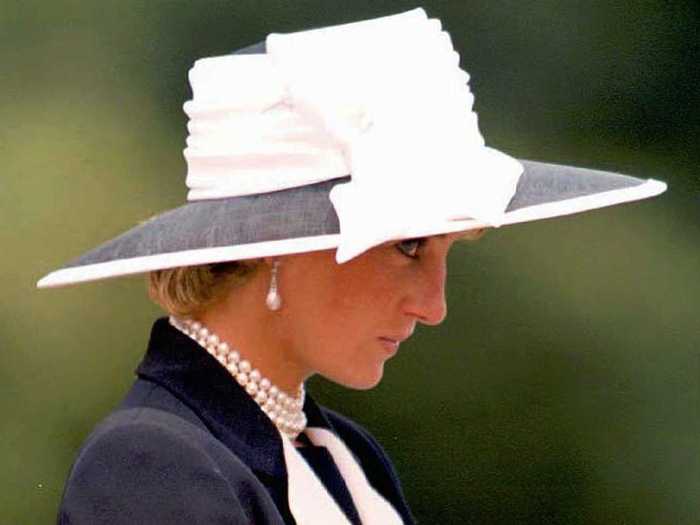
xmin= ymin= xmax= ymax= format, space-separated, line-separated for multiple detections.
xmin=136 ymin=318 xmax=333 ymax=479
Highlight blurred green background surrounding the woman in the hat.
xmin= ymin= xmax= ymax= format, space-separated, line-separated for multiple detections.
xmin=0 ymin=0 xmax=700 ymax=525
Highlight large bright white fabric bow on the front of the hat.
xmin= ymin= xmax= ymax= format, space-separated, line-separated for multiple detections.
xmin=267 ymin=9 xmax=522 ymax=262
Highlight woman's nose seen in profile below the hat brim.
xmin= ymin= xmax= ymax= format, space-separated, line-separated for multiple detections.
xmin=405 ymin=254 xmax=447 ymax=326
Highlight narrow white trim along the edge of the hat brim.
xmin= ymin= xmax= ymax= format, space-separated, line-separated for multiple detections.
xmin=37 ymin=179 xmax=666 ymax=288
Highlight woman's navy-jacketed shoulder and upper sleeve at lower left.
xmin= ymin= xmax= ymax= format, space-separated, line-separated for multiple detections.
xmin=59 ymin=408 xmax=282 ymax=524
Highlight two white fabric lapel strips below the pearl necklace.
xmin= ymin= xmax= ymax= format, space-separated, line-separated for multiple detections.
xmin=280 ymin=427 xmax=403 ymax=525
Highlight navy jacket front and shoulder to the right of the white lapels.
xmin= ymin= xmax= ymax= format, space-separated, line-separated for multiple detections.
xmin=320 ymin=407 xmax=415 ymax=523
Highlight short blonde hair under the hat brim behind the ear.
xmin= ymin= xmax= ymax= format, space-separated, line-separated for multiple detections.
xmin=147 ymin=259 xmax=260 ymax=317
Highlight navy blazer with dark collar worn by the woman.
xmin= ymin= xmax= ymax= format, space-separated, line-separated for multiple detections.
xmin=58 ymin=319 xmax=414 ymax=525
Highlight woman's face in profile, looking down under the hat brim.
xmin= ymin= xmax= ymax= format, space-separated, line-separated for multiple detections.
xmin=277 ymin=234 xmax=459 ymax=389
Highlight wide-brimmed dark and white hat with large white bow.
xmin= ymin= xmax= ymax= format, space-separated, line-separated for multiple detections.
xmin=38 ymin=9 xmax=666 ymax=288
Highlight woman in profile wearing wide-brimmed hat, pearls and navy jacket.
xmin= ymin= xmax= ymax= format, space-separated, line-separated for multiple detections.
xmin=39 ymin=10 xmax=665 ymax=524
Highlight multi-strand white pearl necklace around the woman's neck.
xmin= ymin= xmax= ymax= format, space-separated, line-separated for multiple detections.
xmin=170 ymin=316 xmax=306 ymax=441
